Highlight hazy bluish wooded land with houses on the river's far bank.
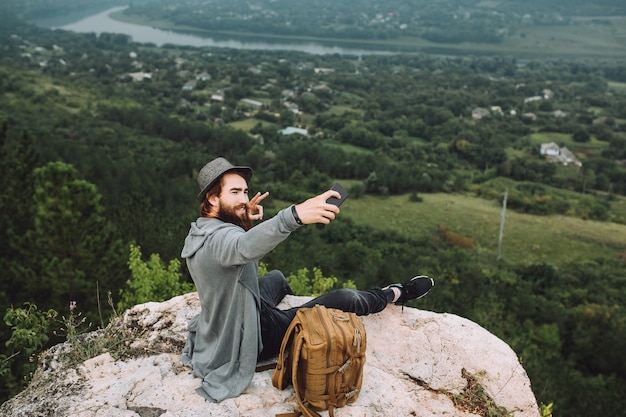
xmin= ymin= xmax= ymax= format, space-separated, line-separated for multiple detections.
xmin=120 ymin=0 xmax=626 ymax=43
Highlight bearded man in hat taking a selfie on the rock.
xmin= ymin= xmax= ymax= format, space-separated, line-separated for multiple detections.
xmin=181 ymin=158 xmax=434 ymax=402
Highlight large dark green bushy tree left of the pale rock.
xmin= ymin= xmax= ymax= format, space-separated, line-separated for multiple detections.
xmin=20 ymin=162 xmax=123 ymax=321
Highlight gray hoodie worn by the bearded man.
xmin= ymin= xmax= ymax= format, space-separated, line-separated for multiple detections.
xmin=181 ymin=208 xmax=299 ymax=402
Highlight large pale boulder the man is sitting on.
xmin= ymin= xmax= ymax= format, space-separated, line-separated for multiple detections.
xmin=0 ymin=293 xmax=539 ymax=417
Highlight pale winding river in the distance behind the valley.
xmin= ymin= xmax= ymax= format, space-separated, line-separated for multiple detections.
xmin=34 ymin=6 xmax=397 ymax=56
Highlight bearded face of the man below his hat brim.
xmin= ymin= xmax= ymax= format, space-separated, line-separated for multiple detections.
xmin=211 ymin=172 xmax=252 ymax=230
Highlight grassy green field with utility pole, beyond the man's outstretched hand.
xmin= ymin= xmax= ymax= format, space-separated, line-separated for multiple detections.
xmin=341 ymin=194 xmax=626 ymax=265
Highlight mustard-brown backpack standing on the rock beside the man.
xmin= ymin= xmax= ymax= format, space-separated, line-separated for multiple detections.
xmin=272 ymin=305 xmax=366 ymax=417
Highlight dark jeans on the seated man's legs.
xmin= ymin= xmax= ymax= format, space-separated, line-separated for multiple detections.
xmin=259 ymin=270 xmax=394 ymax=360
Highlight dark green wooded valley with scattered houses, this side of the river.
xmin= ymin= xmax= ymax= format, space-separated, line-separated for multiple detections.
xmin=0 ymin=3 xmax=626 ymax=417
